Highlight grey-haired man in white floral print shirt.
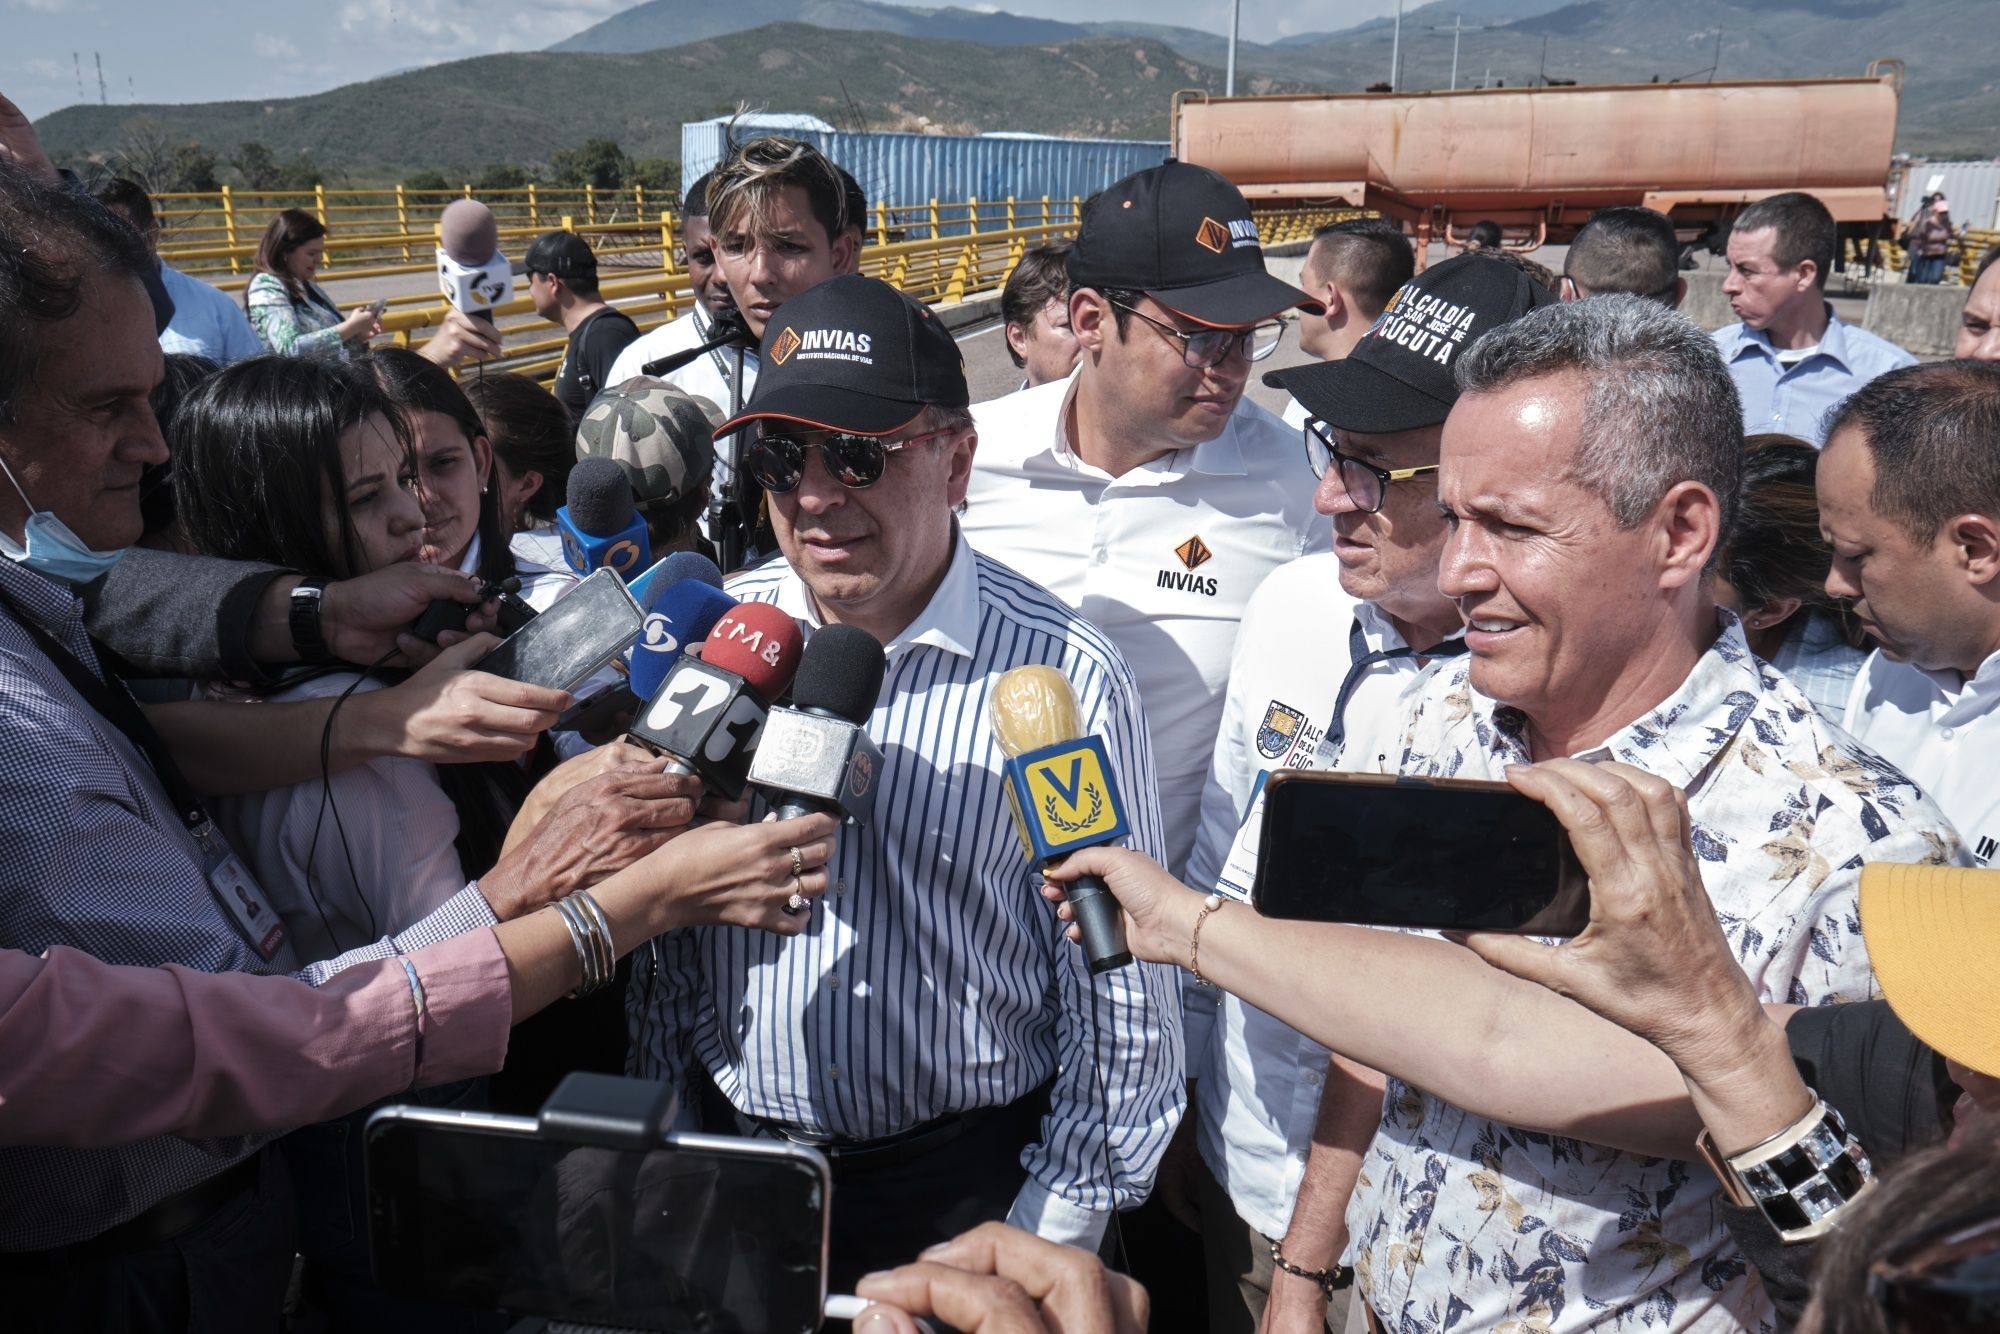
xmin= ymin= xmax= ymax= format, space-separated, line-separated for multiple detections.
xmin=1348 ymin=296 xmax=1960 ymax=1334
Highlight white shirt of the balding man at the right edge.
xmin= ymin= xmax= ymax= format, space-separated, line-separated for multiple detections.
xmin=1842 ymin=650 xmax=2000 ymax=866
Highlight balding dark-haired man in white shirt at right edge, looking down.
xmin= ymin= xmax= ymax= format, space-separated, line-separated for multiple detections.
xmin=1818 ymin=362 xmax=2000 ymax=866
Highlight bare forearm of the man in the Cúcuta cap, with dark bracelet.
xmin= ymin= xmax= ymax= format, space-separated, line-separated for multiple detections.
xmin=1264 ymin=1056 xmax=1386 ymax=1330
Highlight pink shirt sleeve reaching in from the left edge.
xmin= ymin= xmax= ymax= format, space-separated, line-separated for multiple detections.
xmin=0 ymin=930 xmax=514 ymax=1148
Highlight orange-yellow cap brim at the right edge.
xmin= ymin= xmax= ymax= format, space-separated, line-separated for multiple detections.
xmin=1862 ymin=862 xmax=2000 ymax=1078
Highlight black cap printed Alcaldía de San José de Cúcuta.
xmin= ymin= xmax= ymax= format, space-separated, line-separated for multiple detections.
xmin=1264 ymin=254 xmax=1556 ymax=436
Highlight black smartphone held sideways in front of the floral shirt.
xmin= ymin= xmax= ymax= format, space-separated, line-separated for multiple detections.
xmin=1250 ymin=770 xmax=1590 ymax=936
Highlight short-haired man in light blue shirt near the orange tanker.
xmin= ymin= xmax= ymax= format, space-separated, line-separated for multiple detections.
xmin=1714 ymin=192 xmax=1916 ymax=446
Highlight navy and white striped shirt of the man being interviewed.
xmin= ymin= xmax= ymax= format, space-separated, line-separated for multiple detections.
xmin=630 ymin=538 xmax=1186 ymax=1242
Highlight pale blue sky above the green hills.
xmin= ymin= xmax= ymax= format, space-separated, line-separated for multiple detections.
xmin=0 ymin=0 xmax=1418 ymax=116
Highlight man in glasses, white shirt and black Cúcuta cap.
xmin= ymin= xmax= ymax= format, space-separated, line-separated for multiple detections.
xmin=1162 ymin=256 xmax=1554 ymax=1334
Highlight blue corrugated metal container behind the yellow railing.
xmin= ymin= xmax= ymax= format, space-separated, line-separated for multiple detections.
xmin=680 ymin=122 xmax=1166 ymax=236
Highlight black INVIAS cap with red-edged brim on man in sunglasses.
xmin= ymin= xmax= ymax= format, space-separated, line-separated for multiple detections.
xmin=716 ymin=274 xmax=972 ymax=436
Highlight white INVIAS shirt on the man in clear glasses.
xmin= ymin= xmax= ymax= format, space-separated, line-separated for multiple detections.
xmin=960 ymin=370 xmax=1332 ymax=872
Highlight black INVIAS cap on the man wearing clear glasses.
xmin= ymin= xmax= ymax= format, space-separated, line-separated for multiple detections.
xmin=1070 ymin=162 xmax=1326 ymax=326
